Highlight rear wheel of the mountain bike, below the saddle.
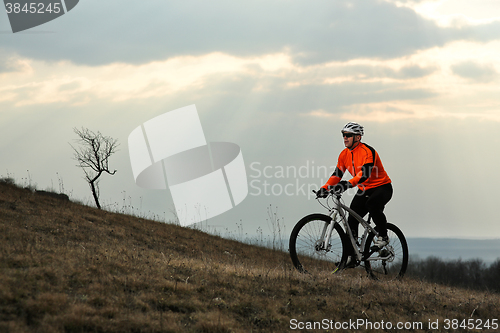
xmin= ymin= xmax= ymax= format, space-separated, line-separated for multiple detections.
xmin=364 ymin=223 xmax=408 ymax=281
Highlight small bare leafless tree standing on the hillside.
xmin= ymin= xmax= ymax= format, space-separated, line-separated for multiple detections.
xmin=70 ymin=127 xmax=118 ymax=209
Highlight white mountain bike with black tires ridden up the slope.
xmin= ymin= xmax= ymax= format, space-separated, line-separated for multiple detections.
xmin=289 ymin=190 xmax=408 ymax=280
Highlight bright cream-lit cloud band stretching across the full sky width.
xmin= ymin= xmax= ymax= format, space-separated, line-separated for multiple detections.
xmin=0 ymin=38 xmax=500 ymax=127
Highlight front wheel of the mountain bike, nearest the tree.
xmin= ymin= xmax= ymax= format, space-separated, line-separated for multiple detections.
xmin=289 ymin=214 xmax=347 ymax=274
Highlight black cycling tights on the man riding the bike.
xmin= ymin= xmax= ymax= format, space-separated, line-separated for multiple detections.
xmin=347 ymin=183 xmax=393 ymax=252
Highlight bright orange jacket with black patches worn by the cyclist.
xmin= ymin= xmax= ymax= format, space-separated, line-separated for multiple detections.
xmin=322 ymin=142 xmax=391 ymax=190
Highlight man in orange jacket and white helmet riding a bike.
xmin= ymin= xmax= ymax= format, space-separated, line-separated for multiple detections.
xmin=317 ymin=122 xmax=393 ymax=266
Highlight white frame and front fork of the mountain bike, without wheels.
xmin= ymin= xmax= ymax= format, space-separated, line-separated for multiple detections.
xmin=322 ymin=193 xmax=378 ymax=261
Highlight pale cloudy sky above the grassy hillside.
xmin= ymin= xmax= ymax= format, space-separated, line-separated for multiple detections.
xmin=0 ymin=0 xmax=500 ymax=239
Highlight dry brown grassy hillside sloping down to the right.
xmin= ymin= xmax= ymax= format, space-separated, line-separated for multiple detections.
xmin=0 ymin=183 xmax=500 ymax=333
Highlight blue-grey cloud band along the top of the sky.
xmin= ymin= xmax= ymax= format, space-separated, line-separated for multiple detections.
xmin=2 ymin=0 xmax=500 ymax=66
